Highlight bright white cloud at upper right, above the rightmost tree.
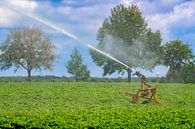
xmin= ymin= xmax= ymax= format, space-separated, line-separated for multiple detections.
xmin=146 ymin=1 xmax=195 ymax=42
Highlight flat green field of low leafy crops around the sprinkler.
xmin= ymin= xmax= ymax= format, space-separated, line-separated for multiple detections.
xmin=0 ymin=82 xmax=195 ymax=129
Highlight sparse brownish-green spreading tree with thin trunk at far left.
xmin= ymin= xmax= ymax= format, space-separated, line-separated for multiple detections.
xmin=0 ymin=27 xmax=56 ymax=80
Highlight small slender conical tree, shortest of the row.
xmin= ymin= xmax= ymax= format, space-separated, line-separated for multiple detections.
xmin=66 ymin=48 xmax=90 ymax=81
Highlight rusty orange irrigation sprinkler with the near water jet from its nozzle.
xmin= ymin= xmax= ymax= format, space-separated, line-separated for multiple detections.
xmin=88 ymin=44 xmax=160 ymax=104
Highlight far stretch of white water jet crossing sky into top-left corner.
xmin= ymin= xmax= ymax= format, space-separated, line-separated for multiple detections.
xmin=1 ymin=2 xmax=78 ymax=40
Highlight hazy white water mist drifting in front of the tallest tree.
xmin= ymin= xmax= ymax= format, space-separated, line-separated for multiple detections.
xmin=96 ymin=34 xmax=158 ymax=69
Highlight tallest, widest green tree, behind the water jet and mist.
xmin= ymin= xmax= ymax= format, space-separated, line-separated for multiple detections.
xmin=90 ymin=4 xmax=161 ymax=81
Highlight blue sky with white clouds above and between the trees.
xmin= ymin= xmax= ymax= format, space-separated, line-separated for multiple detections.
xmin=0 ymin=0 xmax=195 ymax=77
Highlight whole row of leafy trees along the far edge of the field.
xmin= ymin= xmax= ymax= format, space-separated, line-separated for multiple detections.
xmin=0 ymin=4 xmax=195 ymax=82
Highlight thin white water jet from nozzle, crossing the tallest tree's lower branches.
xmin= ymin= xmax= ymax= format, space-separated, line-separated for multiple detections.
xmin=88 ymin=44 xmax=135 ymax=71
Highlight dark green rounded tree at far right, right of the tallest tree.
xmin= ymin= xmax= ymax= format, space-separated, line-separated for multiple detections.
xmin=162 ymin=40 xmax=194 ymax=80
